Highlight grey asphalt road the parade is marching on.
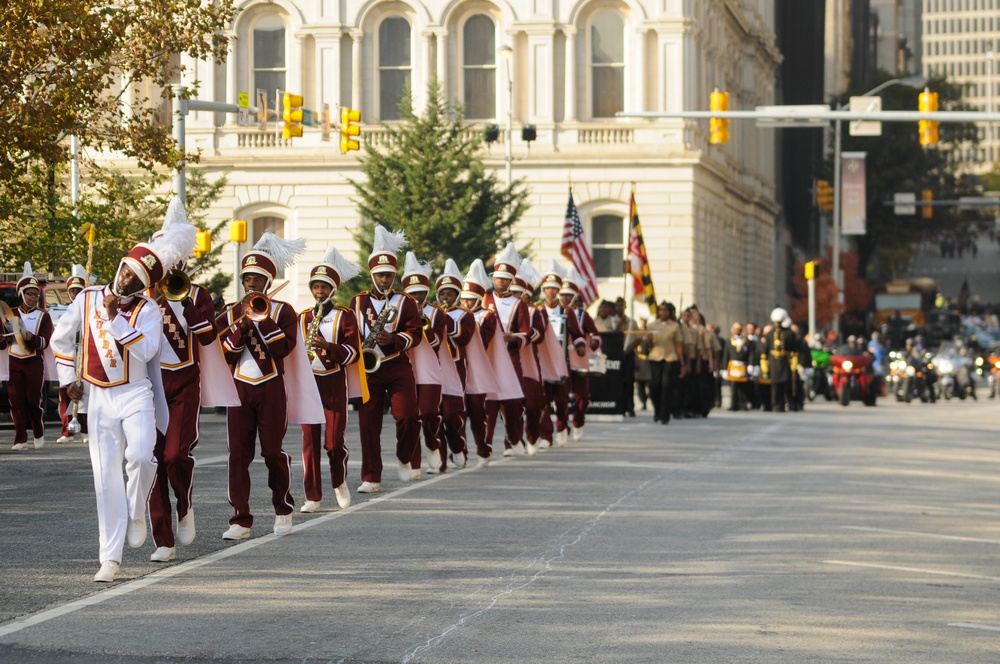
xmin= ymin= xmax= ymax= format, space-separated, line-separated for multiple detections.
xmin=0 ymin=399 xmax=1000 ymax=664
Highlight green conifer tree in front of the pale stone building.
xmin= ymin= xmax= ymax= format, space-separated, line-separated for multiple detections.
xmin=340 ymin=78 xmax=528 ymax=297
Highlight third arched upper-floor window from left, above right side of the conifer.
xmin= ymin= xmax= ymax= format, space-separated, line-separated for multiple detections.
xmin=462 ymin=14 xmax=497 ymax=120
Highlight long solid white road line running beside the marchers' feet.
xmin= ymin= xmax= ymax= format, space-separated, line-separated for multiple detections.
xmin=0 ymin=459 xmax=480 ymax=638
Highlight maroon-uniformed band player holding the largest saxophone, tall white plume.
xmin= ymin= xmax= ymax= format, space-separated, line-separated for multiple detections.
xmin=351 ymin=225 xmax=423 ymax=493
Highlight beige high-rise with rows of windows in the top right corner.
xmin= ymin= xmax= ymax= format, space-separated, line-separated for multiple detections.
xmin=922 ymin=0 xmax=1000 ymax=172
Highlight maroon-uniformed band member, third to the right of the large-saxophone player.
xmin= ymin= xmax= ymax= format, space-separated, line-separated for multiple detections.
xmin=459 ymin=258 xmax=524 ymax=467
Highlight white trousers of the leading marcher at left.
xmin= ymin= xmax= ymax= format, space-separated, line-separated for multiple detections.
xmin=87 ymin=379 xmax=156 ymax=564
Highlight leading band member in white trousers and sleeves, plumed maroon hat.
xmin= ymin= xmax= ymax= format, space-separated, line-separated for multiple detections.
xmin=52 ymin=233 xmax=179 ymax=582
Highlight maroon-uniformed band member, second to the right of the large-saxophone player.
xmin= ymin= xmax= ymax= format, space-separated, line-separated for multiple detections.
xmin=434 ymin=258 xmax=486 ymax=472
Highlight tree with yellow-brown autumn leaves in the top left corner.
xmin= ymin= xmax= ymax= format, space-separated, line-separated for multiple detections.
xmin=0 ymin=0 xmax=234 ymax=223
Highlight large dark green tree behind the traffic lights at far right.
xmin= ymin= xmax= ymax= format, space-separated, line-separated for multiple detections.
xmin=828 ymin=72 xmax=978 ymax=281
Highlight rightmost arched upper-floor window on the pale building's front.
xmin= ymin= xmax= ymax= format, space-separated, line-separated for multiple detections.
xmin=590 ymin=11 xmax=625 ymax=118
